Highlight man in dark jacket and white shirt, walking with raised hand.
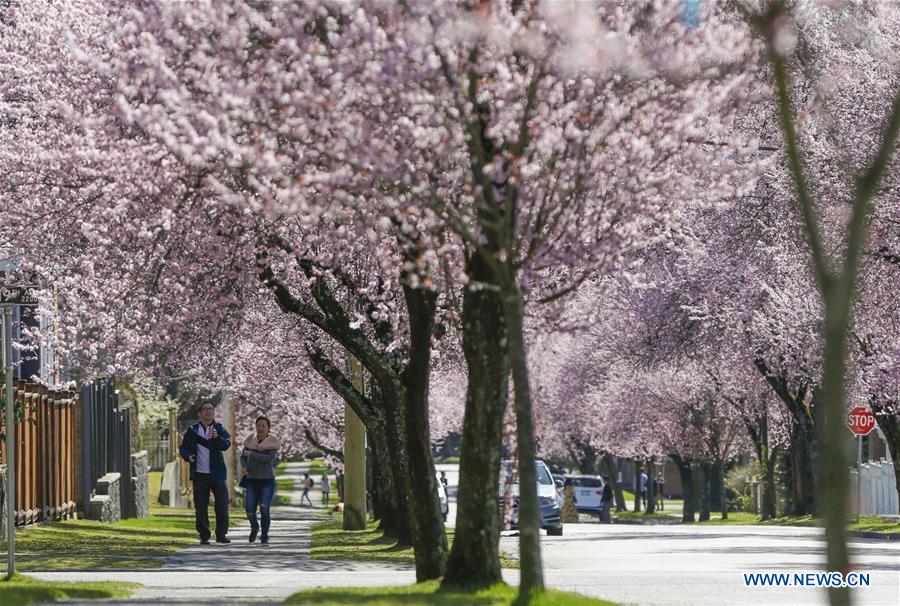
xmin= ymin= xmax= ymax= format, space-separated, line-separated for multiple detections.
xmin=178 ymin=402 xmax=231 ymax=545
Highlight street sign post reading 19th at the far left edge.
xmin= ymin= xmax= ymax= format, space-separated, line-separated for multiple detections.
xmin=0 ymin=284 xmax=38 ymax=579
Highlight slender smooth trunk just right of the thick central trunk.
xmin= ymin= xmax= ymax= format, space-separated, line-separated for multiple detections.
xmin=501 ymin=284 xmax=544 ymax=602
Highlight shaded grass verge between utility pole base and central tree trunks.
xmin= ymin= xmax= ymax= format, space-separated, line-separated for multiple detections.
xmin=309 ymin=514 xmax=519 ymax=568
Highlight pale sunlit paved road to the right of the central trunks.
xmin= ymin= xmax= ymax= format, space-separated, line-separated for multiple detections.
xmin=501 ymin=524 xmax=900 ymax=606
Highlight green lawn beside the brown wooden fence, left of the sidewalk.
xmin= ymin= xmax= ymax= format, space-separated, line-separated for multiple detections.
xmin=0 ymin=512 xmax=197 ymax=570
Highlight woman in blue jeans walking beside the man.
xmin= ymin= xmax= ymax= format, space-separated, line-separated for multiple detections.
xmin=241 ymin=417 xmax=281 ymax=545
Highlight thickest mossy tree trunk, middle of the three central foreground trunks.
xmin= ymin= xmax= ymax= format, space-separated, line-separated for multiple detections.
xmin=443 ymin=255 xmax=509 ymax=587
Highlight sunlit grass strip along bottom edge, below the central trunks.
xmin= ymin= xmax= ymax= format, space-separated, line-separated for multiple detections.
xmin=285 ymin=581 xmax=615 ymax=606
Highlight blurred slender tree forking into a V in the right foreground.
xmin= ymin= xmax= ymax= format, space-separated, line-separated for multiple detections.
xmin=747 ymin=1 xmax=900 ymax=604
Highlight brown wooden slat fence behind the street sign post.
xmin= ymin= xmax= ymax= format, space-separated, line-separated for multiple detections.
xmin=0 ymin=381 xmax=78 ymax=526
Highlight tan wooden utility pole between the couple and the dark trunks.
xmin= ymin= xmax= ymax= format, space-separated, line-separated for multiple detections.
xmin=344 ymin=358 xmax=366 ymax=530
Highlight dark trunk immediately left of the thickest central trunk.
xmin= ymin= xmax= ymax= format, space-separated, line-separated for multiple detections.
xmin=402 ymin=285 xmax=447 ymax=582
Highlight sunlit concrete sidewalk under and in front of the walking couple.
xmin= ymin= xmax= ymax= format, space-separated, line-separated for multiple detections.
xmin=28 ymin=463 xmax=416 ymax=605
